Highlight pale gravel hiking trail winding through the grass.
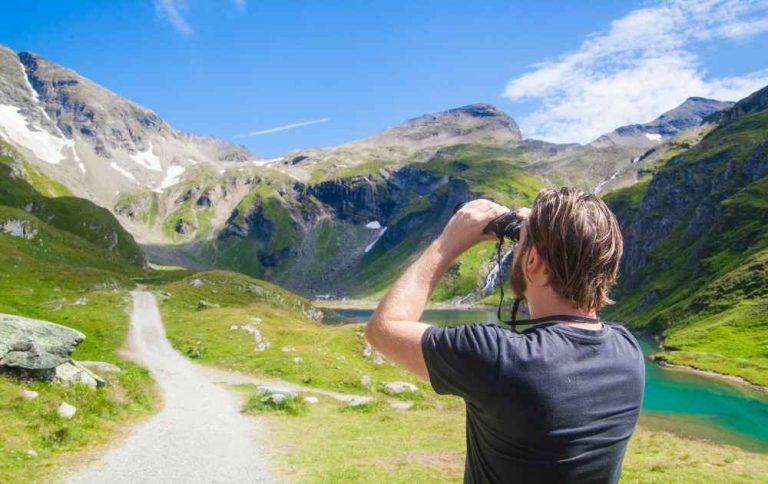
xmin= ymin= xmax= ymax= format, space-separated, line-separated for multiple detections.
xmin=65 ymin=291 xmax=278 ymax=484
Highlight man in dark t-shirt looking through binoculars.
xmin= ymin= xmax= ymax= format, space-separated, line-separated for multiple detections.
xmin=366 ymin=188 xmax=645 ymax=483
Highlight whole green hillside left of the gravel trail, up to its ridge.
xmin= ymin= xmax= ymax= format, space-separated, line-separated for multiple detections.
xmin=0 ymin=139 xmax=156 ymax=482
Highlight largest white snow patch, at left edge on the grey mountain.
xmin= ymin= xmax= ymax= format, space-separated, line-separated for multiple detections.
xmin=0 ymin=104 xmax=69 ymax=165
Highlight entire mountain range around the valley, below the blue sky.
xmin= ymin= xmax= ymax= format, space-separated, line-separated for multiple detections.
xmin=0 ymin=43 xmax=768 ymax=385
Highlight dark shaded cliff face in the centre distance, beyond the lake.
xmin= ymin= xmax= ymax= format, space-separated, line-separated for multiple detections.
xmin=210 ymin=167 xmax=477 ymax=296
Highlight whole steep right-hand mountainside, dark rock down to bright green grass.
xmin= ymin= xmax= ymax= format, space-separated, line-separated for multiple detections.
xmin=605 ymin=86 xmax=768 ymax=385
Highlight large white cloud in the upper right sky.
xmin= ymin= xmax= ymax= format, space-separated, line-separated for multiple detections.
xmin=503 ymin=0 xmax=768 ymax=143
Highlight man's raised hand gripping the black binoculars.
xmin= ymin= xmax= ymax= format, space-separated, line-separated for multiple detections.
xmin=440 ymin=198 xmax=510 ymax=259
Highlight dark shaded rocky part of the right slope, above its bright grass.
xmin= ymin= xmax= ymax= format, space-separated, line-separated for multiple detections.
xmin=608 ymin=84 xmax=768 ymax=327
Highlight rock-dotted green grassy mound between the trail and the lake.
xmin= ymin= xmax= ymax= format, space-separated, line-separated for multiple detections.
xmin=157 ymin=272 xmax=426 ymax=395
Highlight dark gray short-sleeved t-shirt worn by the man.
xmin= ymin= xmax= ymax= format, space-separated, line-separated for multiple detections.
xmin=421 ymin=324 xmax=645 ymax=483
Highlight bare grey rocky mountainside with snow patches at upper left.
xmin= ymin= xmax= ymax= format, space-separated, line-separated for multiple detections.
xmin=0 ymin=46 xmax=255 ymax=207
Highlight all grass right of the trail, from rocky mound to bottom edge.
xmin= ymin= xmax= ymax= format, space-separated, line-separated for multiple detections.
xmin=156 ymin=272 xmax=768 ymax=483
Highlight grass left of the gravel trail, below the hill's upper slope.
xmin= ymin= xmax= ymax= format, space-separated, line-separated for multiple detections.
xmin=0 ymin=216 xmax=156 ymax=482
